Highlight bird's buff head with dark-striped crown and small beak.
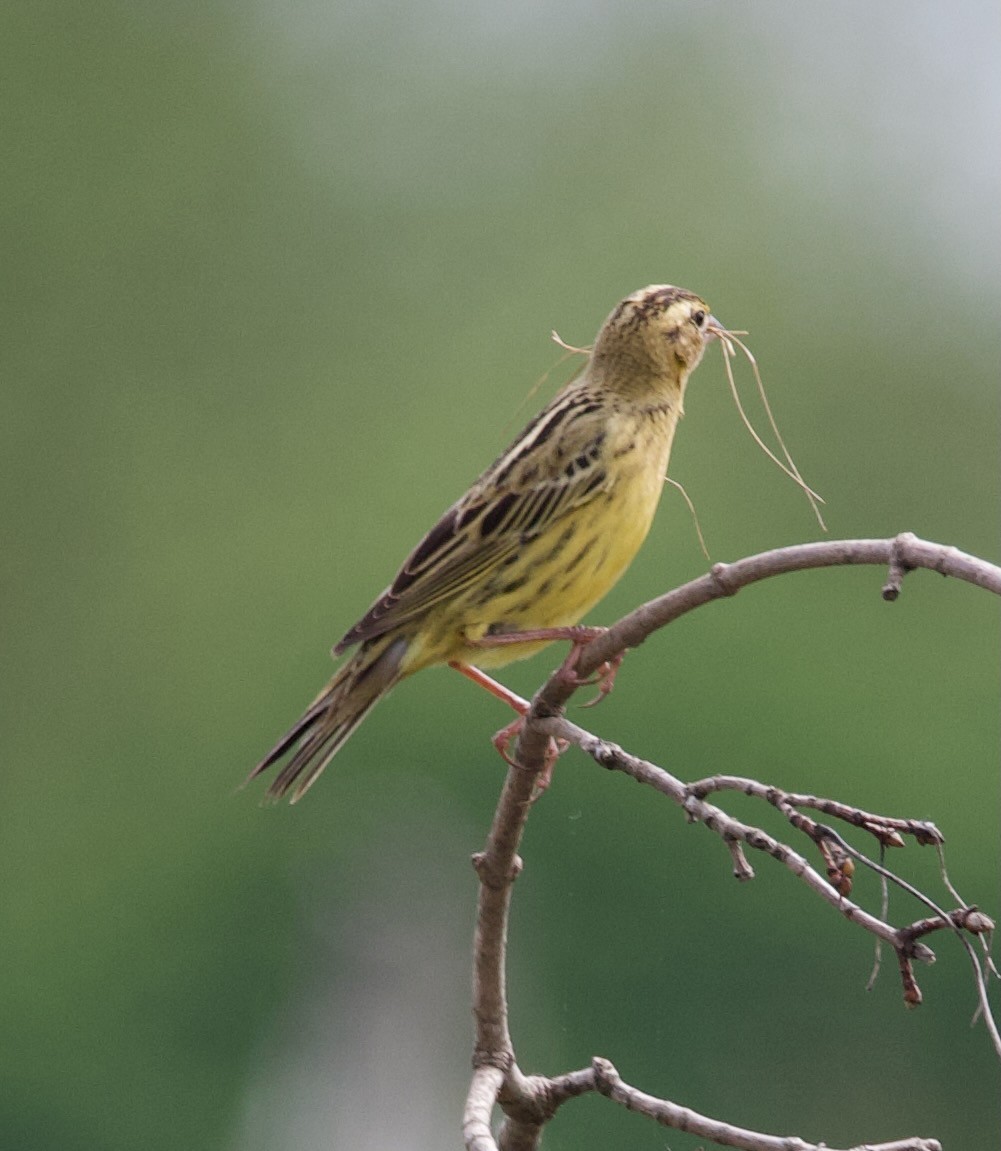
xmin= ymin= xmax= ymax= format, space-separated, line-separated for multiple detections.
xmin=591 ymin=284 xmax=721 ymax=392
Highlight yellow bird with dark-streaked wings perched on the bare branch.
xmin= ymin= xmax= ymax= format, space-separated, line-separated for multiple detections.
xmin=247 ymin=284 xmax=726 ymax=802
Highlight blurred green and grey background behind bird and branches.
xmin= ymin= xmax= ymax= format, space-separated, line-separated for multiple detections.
xmin=0 ymin=0 xmax=1001 ymax=1151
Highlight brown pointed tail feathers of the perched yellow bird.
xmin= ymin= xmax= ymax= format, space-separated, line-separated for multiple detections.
xmin=246 ymin=635 xmax=410 ymax=803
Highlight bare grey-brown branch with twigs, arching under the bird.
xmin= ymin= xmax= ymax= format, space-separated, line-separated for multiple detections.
xmin=464 ymin=533 xmax=1001 ymax=1151
